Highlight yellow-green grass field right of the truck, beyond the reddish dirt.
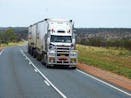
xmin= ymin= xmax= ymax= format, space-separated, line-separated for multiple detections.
xmin=77 ymin=45 xmax=131 ymax=79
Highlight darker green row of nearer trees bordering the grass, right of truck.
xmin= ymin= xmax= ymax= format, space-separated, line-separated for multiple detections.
xmin=77 ymin=38 xmax=131 ymax=50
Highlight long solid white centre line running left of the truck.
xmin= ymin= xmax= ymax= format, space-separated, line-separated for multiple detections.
xmin=20 ymin=49 xmax=67 ymax=98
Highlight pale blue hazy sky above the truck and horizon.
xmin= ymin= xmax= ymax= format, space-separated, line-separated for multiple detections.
xmin=0 ymin=0 xmax=131 ymax=28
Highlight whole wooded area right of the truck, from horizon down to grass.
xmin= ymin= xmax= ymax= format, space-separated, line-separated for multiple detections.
xmin=76 ymin=28 xmax=131 ymax=50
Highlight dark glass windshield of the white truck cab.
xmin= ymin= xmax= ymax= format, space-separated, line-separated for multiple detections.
xmin=51 ymin=35 xmax=72 ymax=43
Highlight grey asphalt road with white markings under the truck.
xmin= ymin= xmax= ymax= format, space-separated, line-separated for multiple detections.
xmin=0 ymin=47 xmax=131 ymax=98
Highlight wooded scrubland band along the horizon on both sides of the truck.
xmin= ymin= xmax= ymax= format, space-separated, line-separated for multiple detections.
xmin=0 ymin=27 xmax=131 ymax=49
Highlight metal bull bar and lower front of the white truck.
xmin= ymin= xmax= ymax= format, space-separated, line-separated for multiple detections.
xmin=47 ymin=47 xmax=78 ymax=66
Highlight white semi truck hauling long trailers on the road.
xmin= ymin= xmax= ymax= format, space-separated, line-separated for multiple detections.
xmin=28 ymin=18 xmax=78 ymax=68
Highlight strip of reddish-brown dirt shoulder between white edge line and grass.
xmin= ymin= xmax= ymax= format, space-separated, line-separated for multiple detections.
xmin=77 ymin=63 xmax=131 ymax=91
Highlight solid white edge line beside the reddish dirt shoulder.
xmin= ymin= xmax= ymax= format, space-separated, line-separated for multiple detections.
xmin=76 ymin=69 xmax=131 ymax=96
